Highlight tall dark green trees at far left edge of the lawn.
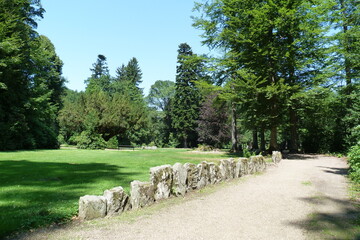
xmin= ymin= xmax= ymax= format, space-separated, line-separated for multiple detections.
xmin=0 ymin=0 xmax=64 ymax=150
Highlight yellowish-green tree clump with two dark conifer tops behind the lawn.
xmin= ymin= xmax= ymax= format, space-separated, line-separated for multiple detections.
xmin=58 ymin=55 xmax=150 ymax=149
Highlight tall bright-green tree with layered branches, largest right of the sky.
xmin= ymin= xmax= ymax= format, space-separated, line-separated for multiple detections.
xmin=194 ymin=0 xmax=327 ymax=152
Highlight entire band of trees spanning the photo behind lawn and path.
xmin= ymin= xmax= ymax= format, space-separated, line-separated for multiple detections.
xmin=0 ymin=0 xmax=360 ymax=152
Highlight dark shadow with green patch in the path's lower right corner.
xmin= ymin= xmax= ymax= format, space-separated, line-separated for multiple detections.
xmin=289 ymin=196 xmax=360 ymax=239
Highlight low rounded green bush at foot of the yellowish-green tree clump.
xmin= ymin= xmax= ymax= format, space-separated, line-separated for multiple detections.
xmin=76 ymin=131 xmax=106 ymax=149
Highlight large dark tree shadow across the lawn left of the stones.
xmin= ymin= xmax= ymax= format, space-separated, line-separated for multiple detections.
xmin=0 ymin=160 xmax=137 ymax=239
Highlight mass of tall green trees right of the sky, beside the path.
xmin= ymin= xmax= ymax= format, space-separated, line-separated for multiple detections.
xmin=190 ymin=0 xmax=360 ymax=152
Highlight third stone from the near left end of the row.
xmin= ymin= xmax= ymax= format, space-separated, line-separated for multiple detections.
xmin=130 ymin=181 xmax=155 ymax=209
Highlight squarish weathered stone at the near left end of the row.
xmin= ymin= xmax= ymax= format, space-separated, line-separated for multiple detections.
xmin=79 ymin=195 xmax=106 ymax=220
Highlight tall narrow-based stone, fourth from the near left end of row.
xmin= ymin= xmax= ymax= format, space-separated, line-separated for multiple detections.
xmin=150 ymin=165 xmax=173 ymax=201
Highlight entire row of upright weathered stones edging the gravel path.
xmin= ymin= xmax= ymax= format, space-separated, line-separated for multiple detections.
xmin=79 ymin=151 xmax=282 ymax=220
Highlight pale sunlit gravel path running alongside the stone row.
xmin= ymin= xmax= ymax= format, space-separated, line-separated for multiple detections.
xmin=19 ymin=155 xmax=351 ymax=240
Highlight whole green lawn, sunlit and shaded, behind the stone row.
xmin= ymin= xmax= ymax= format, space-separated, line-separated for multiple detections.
xmin=0 ymin=149 xmax=230 ymax=238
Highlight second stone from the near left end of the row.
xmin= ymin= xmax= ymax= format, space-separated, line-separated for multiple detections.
xmin=104 ymin=187 xmax=130 ymax=215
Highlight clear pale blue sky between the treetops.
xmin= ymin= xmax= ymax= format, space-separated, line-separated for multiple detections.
xmin=37 ymin=0 xmax=209 ymax=95
